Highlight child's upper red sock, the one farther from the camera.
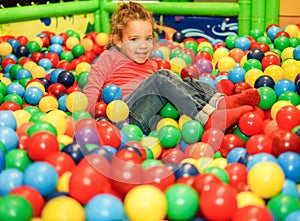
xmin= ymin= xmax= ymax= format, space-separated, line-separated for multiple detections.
xmin=218 ymin=88 xmax=260 ymax=109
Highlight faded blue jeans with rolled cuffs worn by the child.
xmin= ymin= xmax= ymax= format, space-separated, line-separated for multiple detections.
xmin=124 ymin=70 xmax=224 ymax=134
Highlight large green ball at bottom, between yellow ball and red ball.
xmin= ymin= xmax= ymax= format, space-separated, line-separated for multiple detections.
xmin=165 ymin=183 xmax=199 ymax=220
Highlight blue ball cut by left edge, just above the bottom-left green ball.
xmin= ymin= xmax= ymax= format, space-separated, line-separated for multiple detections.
xmin=0 ymin=168 xmax=23 ymax=196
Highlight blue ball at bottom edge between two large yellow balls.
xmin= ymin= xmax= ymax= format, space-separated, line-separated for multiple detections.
xmin=84 ymin=193 xmax=125 ymax=221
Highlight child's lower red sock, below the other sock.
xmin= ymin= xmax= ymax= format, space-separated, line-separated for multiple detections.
xmin=204 ymin=105 xmax=253 ymax=131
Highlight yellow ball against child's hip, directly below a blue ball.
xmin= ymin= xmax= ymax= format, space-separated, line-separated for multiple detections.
xmin=106 ymin=100 xmax=129 ymax=122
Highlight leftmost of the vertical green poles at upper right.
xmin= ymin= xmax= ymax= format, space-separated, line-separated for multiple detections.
xmin=238 ymin=0 xmax=252 ymax=36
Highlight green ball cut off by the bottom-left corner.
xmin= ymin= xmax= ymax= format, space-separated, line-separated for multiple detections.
xmin=0 ymin=195 xmax=33 ymax=221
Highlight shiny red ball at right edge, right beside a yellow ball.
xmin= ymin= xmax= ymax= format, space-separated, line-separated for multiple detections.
xmin=276 ymin=105 xmax=300 ymax=131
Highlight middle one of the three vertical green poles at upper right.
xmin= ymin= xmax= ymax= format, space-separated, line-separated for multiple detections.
xmin=251 ymin=0 xmax=266 ymax=31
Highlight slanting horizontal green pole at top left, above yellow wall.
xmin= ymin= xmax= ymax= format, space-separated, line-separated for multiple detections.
xmin=0 ymin=1 xmax=99 ymax=24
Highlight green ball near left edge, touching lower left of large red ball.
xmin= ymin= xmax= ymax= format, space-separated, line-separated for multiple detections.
xmin=5 ymin=149 xmax=32 ymax=172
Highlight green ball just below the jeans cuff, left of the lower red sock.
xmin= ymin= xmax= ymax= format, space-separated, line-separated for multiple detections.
xmin=181 ymin=120 xmax=204 ymax=144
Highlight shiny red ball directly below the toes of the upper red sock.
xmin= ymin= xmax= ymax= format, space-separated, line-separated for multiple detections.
xmin=238 ymin=111 xmax=263 ymax=136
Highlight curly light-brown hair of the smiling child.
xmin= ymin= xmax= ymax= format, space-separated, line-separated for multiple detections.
xmin=111 ymin=1 xmax=154 ymax=43
